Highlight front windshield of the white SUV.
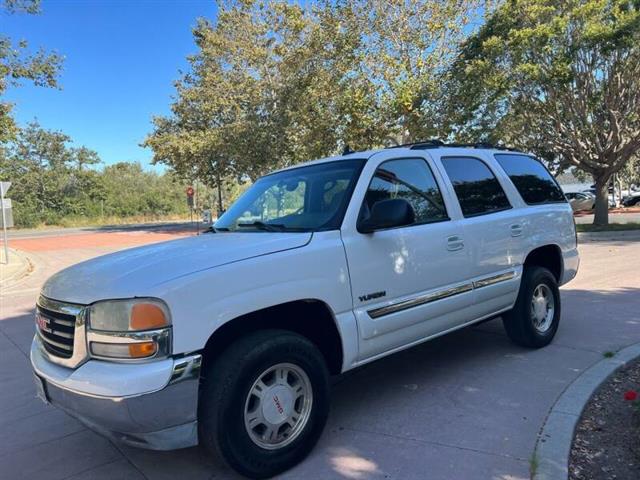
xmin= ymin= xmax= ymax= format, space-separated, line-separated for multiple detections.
xmin=214 ymin=159 xmax=365 ymax=232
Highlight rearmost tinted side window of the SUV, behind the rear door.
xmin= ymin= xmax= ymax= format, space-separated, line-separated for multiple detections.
xmin=495 ymin=153 xmax=565 ymax=205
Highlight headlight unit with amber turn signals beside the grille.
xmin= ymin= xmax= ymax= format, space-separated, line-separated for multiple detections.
xmin=87 ymin=298 xmax=171 ymax=361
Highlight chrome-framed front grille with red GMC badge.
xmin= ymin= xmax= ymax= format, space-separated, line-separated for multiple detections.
xmin=36 ymin=296 xmax=87 ymax=368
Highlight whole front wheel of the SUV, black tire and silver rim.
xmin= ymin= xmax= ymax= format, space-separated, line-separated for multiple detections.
xmin=198 ymin=330 xmax=329 ymax=478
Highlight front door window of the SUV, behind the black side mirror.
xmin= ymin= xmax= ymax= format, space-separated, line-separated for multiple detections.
xmin=361 ymin=159 xmax=449 ymax=224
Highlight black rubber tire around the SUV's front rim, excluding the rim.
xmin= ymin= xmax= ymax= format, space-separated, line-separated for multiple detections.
xmin=198 ymin=330 xmax=330 ymax=478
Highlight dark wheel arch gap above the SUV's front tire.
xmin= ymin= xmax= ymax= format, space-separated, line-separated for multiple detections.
xmin=203 ymin=298 xmax=344 ymax=375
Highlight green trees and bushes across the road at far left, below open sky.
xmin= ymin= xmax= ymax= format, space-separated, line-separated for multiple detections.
xmin=0 ymin=122 xmax=194 ymax=227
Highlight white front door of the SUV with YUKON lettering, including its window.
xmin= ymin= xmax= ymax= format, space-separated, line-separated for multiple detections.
xmin=341 ymin=152 xmax=474 ymax=362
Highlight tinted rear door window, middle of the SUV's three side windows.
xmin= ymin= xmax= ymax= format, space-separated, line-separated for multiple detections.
xmin=442 ymin=157 xmax=511 ymax=217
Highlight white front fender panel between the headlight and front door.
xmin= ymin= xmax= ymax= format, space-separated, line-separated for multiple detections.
xmin=158 ymin=232 xmax=357 ymax=364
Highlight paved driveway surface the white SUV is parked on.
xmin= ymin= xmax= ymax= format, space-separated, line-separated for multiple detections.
xmin=0 ymin=231 xmax=640 ymax=480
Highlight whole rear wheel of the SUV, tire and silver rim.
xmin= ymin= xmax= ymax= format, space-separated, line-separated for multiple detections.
xmin=502 ymin=267 xmax=560 ymax=348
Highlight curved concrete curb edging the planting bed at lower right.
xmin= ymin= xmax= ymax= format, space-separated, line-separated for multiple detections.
xmin=532 ymin=342 xmax=640 ymax=480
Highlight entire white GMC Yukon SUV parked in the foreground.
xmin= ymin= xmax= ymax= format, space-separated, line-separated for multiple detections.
xmin=31 ymin=142 xmax=579 ymax=478
